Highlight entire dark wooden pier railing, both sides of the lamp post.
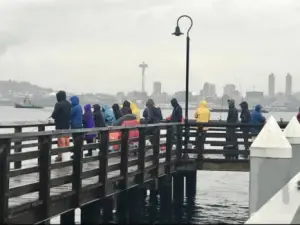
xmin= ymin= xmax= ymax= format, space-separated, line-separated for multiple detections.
xmin=0 ymin=119 xmax=284 ymax=223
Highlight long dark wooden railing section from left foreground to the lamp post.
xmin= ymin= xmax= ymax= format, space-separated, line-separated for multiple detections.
xmin=0 ymin=124 xmax=181 ymax=223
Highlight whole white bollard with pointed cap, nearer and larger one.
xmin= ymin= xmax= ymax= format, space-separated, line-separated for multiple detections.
xmin=249 ymin=116 xmax=292 ymax=216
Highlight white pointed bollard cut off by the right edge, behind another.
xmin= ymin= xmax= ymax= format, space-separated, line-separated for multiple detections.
xmin=283 ymin=116 xmax=300 ymax=178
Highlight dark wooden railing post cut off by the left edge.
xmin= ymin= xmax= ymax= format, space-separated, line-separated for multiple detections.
xmin=0 ymin=139 xmax=11 ymax=224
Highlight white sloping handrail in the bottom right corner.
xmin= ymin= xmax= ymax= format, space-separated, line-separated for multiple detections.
xmin=245 ymin=172 xmax=300 ymax=224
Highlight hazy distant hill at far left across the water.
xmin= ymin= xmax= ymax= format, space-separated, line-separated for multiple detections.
xmin=0 ymin=80 xmax=53 ymax=95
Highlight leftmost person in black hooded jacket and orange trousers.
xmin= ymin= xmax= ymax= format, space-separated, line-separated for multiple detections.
xmin=51 ymin=91 xmax=72 ymax=162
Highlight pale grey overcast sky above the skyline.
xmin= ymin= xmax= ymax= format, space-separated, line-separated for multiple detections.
xmin=0 ymin=0 xmax=300 ymax=94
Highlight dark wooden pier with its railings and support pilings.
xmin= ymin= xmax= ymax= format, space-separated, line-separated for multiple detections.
xmin=0 ymin=122 xmax=286 ymax=224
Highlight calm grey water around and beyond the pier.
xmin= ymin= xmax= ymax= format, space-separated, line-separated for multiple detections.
xmin=0 ymin=107 xmax=295 ymax=223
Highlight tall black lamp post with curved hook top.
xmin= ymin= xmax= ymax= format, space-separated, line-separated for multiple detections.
xmin=173 ymin=15 xmax=193 ymax=158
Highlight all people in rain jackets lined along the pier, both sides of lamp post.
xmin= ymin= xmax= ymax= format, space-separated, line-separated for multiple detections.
xmin=51 ymin=91 xmax=265 ymax=161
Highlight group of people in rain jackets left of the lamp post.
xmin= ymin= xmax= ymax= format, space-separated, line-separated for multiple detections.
xmin=51 ymin=91 xmax=182 ymax=161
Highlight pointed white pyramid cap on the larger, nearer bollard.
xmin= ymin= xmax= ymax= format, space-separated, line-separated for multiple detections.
xmin=250 ymin=116 xmax=292 ymax=158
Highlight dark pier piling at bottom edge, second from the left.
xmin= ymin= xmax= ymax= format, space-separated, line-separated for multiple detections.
xmin=81 ymin=201 xmax=101 ymax=224
